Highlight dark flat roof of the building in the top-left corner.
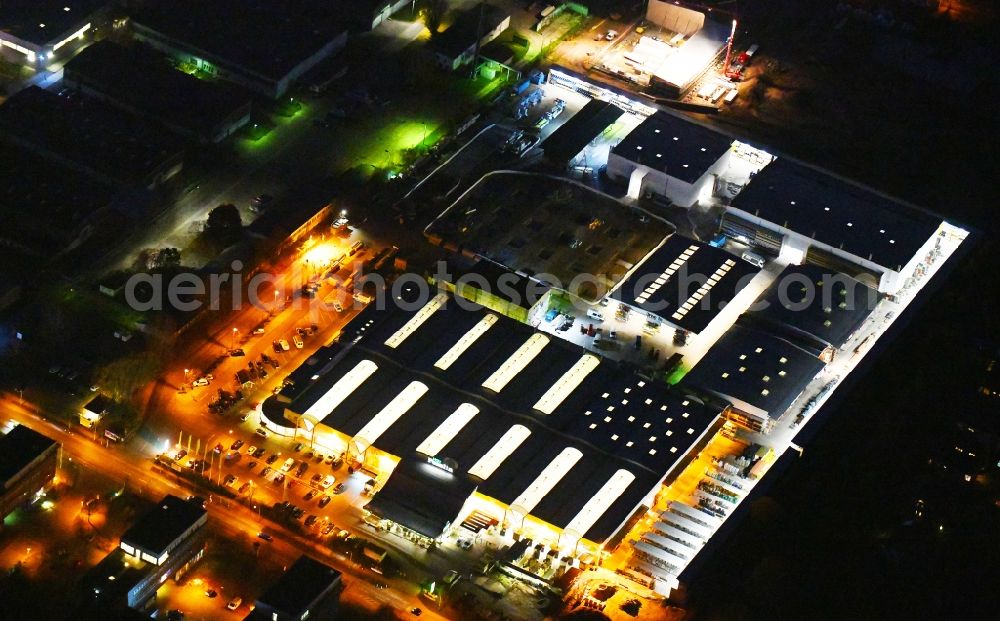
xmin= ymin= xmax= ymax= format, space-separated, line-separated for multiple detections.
xmin=0 ymin=0 xmax=110 ymax=45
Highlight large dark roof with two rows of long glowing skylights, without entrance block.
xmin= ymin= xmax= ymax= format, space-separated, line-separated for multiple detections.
xmin=289 ymin=283 xmax=717 ymax=540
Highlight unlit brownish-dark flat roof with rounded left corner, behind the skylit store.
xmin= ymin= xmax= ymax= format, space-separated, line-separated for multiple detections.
xmin=427 ymin=172 xmax=674 ymax=302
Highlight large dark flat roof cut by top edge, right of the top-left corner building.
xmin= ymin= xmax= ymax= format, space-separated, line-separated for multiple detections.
xmin=133 ymin=0 xmax=346 ymax=80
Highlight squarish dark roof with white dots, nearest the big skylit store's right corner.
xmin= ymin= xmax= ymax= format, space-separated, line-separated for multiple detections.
xmin=683 ymin=324 xmax=824 ymax=418
